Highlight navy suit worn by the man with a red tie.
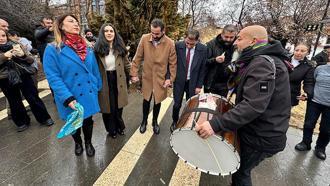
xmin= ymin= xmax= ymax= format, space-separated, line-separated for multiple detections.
xmin=172 ymin=41 xmax=207 ymax=122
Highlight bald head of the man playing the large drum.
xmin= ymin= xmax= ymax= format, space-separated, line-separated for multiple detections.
xmin=235 ymin=25 xmax=268 ymax=51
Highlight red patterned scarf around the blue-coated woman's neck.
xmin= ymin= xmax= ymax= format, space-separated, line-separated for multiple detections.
xmin=64 ymin=33 xmax=87 ymax=62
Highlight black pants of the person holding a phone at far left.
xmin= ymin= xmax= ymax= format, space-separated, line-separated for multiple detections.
xmin=0 ymin=75 xmax=50 ymax=126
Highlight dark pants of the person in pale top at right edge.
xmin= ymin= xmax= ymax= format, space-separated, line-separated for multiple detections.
xmin=303 ymin=101 xmax=330 ymax=150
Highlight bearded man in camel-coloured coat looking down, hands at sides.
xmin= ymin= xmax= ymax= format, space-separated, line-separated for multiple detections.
xmin=130 ymin=19 xmax=177 ymax=134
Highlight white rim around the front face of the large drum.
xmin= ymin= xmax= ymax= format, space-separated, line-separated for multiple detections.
xmin=170 ymin=128 xmax=241 ymax=176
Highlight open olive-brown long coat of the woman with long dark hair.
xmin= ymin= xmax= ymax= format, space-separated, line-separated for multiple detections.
xmin=97 ymin=52 xmax=130 ymax=113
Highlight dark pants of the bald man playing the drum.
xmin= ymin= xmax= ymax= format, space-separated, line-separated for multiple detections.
xmin=232 ymin=143 xmax=273 ymax=186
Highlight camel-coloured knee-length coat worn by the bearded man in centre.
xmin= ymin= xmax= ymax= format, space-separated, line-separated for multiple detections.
xmin=130 ymin=34 xmax=176 ymax=104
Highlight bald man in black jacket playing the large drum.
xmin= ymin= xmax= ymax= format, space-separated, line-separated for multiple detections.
xmin=196 ymin=25 xmax=291 ymax=185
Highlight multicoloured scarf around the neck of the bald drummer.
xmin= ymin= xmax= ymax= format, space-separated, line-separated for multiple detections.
xmin=227 ymin=40 xmax=268 ymax=92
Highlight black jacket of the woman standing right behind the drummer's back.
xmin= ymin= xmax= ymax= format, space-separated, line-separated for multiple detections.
xmin=290 ymin=58 xmax=314 ymax=106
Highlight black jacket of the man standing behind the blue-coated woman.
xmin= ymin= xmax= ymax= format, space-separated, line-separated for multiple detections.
xmin=34 ymin=26 xmax=54 ymax=62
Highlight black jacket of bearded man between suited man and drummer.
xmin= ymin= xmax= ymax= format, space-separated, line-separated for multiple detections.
xmin=204 ymin=35 xmax=234 ymax=93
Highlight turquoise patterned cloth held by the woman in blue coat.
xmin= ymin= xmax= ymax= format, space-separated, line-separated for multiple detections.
xmin=57 ymin=103 xmax=84 ymax=139
